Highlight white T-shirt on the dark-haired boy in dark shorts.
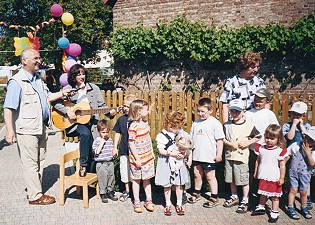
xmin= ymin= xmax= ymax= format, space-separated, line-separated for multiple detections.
xmin=190 ymin=116 xmax=225 ymax=163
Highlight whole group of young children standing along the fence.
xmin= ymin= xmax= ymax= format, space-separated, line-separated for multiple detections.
xmin=93 ymin=88 xmax=315 ymax=223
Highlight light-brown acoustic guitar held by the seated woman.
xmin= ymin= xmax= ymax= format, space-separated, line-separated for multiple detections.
xmin=51 ymin=101 xmax=122 ymax=130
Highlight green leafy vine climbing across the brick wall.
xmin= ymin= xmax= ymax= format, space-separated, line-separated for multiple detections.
xmin=110 ymin=12 xmax=315 ymax=65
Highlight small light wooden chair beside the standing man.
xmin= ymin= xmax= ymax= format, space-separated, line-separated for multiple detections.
xmin=59 ymin=149 xmax=100 ymax=208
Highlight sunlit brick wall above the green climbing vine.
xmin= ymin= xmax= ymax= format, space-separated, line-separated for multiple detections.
xmin=113 ymin=0 xmax=315 ymax=27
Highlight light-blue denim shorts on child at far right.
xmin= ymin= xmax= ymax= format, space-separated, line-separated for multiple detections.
xmin=289 ymin=169 xmax=312 ymax=192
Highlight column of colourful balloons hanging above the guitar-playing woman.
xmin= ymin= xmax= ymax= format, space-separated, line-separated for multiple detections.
xmin=50 ymin=4 xmax=82 ymax=86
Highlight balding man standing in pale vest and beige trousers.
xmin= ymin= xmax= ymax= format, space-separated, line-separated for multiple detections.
xmin=4 ymin=49 xmax=70 ymax=205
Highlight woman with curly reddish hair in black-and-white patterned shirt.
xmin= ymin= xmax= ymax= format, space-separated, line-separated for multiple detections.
xmin=220 ymin=51 xmax=265 ymax=123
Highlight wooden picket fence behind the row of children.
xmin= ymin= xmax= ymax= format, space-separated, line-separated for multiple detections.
xmin=102 ymin=91 xmax=315 ymax=138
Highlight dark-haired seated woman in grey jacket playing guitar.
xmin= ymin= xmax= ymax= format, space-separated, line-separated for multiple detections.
xmin=54 ymin=64 xmax=116 ymax=177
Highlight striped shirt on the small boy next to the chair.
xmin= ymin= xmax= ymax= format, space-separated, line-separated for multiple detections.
xmin=92 ymin=137 xmax=114 ymax=162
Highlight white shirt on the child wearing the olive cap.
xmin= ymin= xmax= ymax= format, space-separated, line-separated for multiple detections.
xmin=245 ymin=108 xmax=279 ymax=144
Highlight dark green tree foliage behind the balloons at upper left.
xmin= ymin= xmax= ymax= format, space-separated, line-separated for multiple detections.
xmin=0 ymin=0 xmax=112 ymax=66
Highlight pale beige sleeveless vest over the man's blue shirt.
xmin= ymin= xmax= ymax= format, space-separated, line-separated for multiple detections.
xmin=11 ymin=70 xmax=49 ymax=135
